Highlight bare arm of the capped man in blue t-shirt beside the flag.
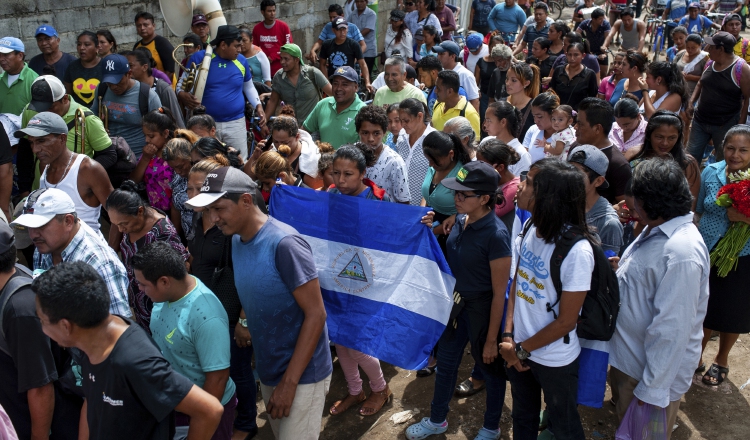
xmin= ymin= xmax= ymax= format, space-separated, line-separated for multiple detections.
xmin=266 ymin=278 xmax=326 ymax=419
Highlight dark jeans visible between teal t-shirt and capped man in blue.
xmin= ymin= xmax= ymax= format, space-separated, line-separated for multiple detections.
xmin=229 ymin=329 xmax=258 ymax=432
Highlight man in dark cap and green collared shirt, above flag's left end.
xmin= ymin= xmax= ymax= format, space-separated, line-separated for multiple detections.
xmin=302 ymin=66 xmax=365 ymax=149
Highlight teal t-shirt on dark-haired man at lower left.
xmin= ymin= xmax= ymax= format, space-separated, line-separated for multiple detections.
xmin=150 ymin=275 xmax=235 ymax=405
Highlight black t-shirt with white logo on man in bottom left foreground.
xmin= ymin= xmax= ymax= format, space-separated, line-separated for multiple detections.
xmin=74 ymin=318 xmax=193 ymax=440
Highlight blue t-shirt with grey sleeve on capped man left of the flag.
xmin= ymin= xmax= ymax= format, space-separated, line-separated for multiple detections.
xmin=232 ymin=217 xmax=333 ymax=386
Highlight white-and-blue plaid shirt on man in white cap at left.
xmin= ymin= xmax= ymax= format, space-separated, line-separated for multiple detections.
xmin=34 ymin=221 xmax=132 ymax=318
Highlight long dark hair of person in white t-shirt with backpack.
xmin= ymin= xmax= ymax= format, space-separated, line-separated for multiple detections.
xmin=531 ymin=157 xmax=594 ymax=243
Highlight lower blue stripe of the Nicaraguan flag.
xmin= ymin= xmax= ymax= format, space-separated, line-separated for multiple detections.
xmin=324 ymin=288 xmax=445 ymax=370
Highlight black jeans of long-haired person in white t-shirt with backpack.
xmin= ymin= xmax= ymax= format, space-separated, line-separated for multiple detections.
xmin=507 ymin=359 xmax=586 ymax=440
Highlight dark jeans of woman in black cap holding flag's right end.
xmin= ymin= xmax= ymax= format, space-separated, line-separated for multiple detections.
xmin=430 ymin=311 xmax=508 ymax=430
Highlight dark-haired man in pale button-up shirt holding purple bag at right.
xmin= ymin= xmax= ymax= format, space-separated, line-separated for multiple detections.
xmin=609 ymin=159 xmax=710 ymax=439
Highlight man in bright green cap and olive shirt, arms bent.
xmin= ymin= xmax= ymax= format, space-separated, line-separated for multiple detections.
xmin=266 ymin=43 xmax=333 ymax=126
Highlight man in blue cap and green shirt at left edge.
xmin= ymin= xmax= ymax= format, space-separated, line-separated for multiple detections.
xmin=0 ymin=37 xmax=39 ymax=115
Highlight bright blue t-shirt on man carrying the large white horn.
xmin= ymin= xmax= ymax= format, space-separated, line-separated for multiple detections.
xmin=188 ymin=50 xmax=253 ymax=122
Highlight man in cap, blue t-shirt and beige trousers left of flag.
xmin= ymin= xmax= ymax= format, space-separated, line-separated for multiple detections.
xmin=187 ymin=167 xmax=333 ymax=439
